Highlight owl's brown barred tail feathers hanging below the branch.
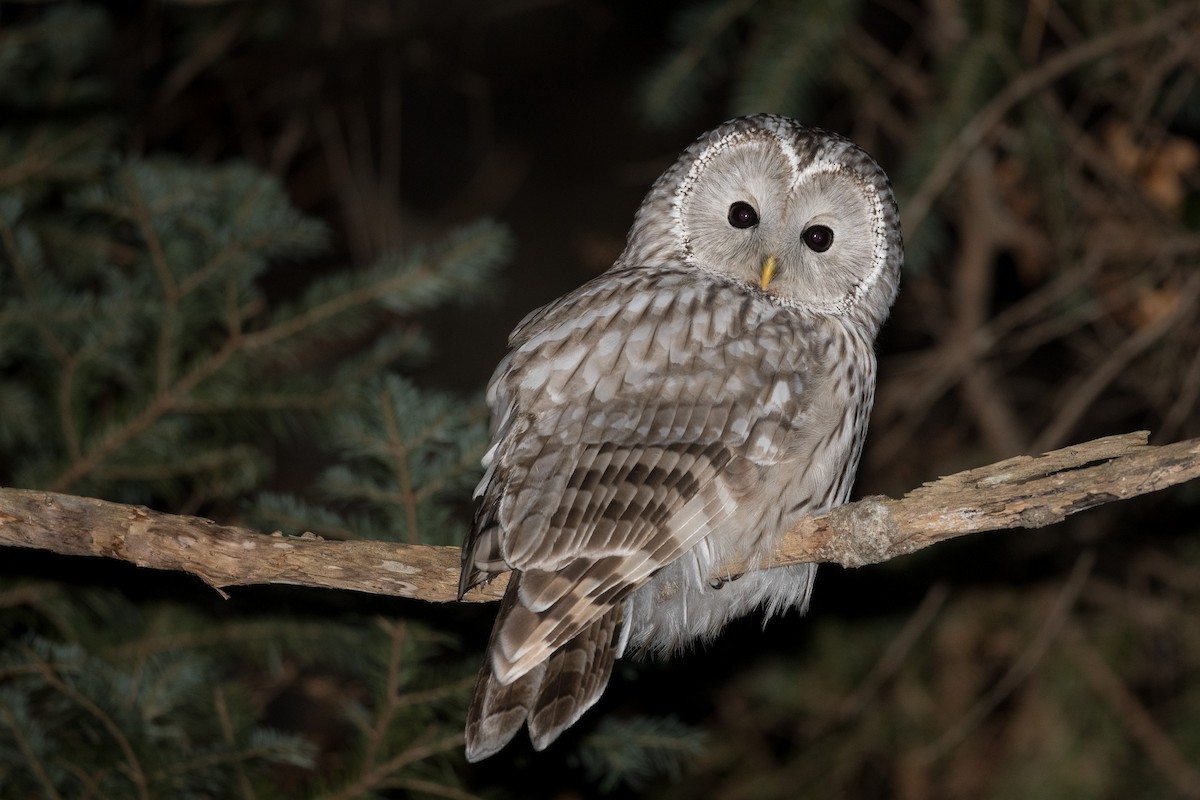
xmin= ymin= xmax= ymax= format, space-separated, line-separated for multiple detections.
xmin=467 ymin=572 xmax=625 ymax=762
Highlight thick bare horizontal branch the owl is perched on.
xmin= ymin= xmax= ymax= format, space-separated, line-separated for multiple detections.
xmin=0 ymin=432 xmax=1200 ymax=602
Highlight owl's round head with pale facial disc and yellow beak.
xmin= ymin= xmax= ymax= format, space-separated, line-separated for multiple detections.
xmin=620 ymin=114 xmax=904 ymax=325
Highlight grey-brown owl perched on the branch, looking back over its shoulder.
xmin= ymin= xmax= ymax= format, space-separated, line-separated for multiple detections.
xmin=460 ymin=115 xmax=904 ymax=760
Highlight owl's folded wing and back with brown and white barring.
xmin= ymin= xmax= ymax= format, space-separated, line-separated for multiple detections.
xmin=461 ymin=267 xmax=811 ymax=684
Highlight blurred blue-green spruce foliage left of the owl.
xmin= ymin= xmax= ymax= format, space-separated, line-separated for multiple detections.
xmin=0 ymin=6 xmax=509 ymax=799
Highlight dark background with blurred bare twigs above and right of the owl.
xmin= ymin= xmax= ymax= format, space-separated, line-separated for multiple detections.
xmin=0 ymin=0 xmax=1200 ymax=798
